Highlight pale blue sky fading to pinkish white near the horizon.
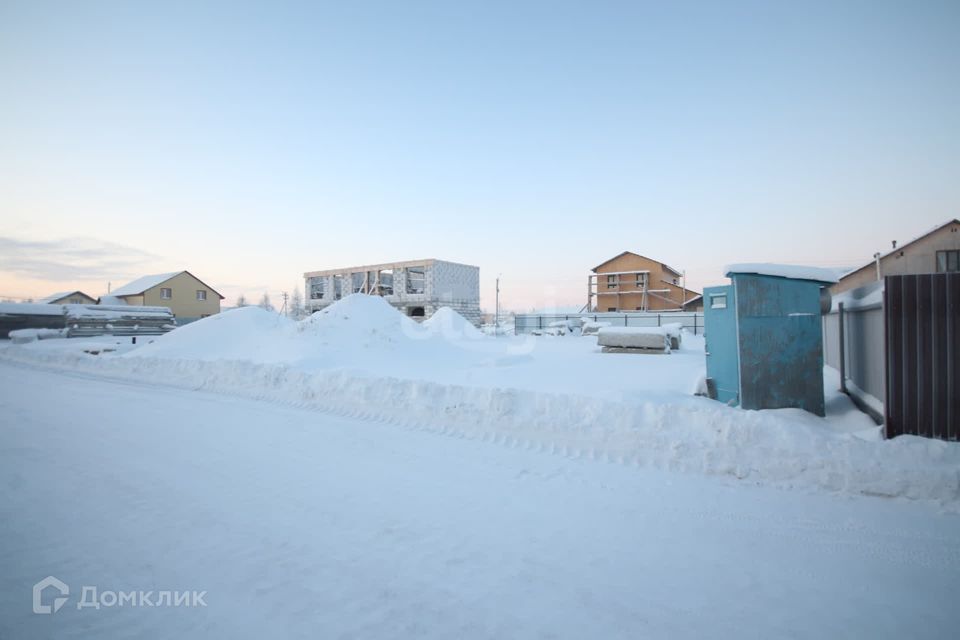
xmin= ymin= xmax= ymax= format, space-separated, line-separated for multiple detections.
xmin=0 ymin=0 xmax=960 ymax=309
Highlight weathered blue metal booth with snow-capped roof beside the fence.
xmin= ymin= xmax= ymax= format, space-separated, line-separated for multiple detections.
xmin=703 ymin=265 xmax=836 ymax=416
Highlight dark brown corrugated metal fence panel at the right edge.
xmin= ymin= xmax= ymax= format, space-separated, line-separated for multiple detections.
xmin=883 ymin=273 xmax=960 ymax=441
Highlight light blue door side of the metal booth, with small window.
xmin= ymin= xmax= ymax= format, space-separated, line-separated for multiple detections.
xmin=703 ymin=285 xmax=740 ymax=405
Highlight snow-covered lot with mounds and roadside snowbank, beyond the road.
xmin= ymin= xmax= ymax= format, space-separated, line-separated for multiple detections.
xmin=0 ymin=296 xmax=960 ymax=504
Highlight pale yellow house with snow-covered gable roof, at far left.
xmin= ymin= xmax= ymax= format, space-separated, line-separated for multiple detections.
xmin=107 ymin=271 xmax=223 ymax=324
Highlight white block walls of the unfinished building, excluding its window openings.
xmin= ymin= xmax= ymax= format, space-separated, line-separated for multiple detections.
xmin=304 ymin=259 xmax=481 ymax=326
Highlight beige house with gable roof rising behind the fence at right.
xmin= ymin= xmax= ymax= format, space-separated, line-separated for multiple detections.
xmin=830 ymin=219 xmax=960 ymax=294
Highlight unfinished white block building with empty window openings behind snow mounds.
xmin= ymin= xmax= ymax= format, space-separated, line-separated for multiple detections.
xmin=303 ymin=258 xmax=481 ymax=325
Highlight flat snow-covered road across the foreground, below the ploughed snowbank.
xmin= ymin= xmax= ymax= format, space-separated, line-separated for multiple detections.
xmin=0 ymin=364 xmax=960 ymax=639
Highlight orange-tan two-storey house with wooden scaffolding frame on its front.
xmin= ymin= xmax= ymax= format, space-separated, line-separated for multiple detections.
xmin=587 ymin=251 xmax=703 ymax=312
